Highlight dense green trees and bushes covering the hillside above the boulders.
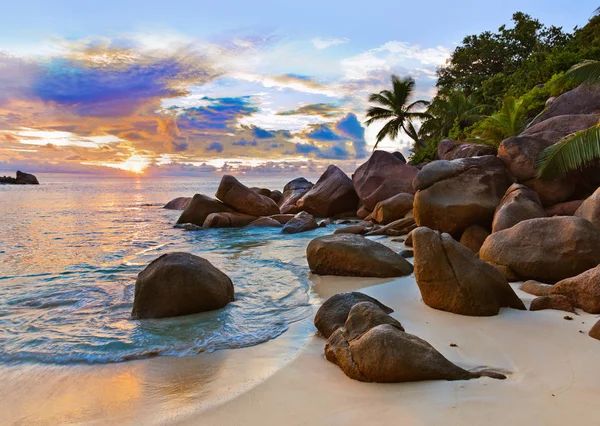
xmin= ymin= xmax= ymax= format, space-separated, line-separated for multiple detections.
xmin=407 ymin=12 xmax=600 ymax=164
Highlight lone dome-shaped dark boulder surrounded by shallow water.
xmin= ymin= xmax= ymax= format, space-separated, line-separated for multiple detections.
xmin=131 ymin=252 xmax=234 ymax=319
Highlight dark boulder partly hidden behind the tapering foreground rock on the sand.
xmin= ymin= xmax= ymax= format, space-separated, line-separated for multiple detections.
xmin=314 ymin=291 xmax=394 ymax=338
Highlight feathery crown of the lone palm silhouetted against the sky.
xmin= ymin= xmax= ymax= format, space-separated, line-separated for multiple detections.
xmin=365 ymin=75 xmax=429 ymax=149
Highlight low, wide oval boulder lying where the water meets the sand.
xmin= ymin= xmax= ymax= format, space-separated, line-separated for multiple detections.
xmin=306 ymin=234 xmax=413 ymax=278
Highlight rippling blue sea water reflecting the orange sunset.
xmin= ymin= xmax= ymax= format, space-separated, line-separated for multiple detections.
xmin=0 ymin=174 xmax=332 ymax=364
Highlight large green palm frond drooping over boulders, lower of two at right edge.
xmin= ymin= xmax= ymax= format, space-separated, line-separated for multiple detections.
xmin=536 ymin=125 xmax=600 ymax=180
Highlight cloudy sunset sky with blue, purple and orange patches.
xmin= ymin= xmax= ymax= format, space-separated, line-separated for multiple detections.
xmin=0 ymin=0 xmax=598 ymax=175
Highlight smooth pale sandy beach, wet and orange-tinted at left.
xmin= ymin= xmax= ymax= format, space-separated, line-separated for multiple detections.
xmin=0 ymin=238 xmax=600 ymax=426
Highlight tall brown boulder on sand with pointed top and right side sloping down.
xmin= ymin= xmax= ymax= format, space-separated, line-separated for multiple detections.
xmin=412 ymin=227 xmax=525 ymax=316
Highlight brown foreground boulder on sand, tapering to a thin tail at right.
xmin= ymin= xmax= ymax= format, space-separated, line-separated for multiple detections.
xmin=325 ymin=302 xmax=505 ymax=383
